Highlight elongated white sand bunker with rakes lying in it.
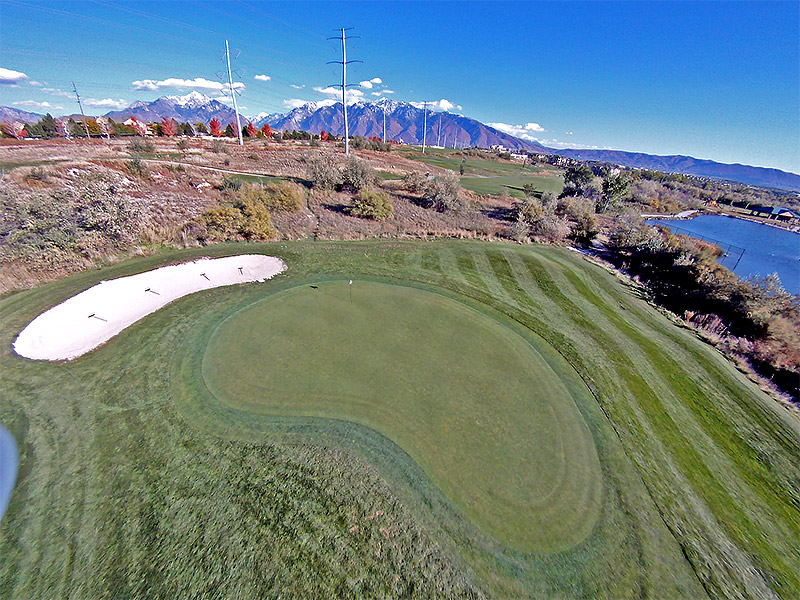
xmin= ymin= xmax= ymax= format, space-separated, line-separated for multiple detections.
xmin=12 ymin=254 xmax=286 ymax=360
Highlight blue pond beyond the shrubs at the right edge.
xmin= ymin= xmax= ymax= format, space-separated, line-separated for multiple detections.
xmin=645 ymin=215 xmax=800 ymax=294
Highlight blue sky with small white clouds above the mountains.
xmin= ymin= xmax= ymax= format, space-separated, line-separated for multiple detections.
xmin=0 ymin=0 xmax=800 ymax=173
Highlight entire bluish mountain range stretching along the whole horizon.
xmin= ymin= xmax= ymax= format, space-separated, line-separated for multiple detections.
xmin=0 ymin=92 xmax=800 ymax=191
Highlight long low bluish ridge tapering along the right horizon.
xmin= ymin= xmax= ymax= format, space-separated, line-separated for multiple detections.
xmin=551 ymin=148 xmax=800 ymax=190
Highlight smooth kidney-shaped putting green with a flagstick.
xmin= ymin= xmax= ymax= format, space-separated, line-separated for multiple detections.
xmin=202 ymin=281 xmax=602 ymax=552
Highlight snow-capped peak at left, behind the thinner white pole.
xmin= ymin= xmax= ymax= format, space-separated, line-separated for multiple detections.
xmin=106 ymin=92 xmax=253 ymax=127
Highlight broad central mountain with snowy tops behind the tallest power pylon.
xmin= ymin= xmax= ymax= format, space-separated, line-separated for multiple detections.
xmin=256 ymin=99 xmax=549 ymax=152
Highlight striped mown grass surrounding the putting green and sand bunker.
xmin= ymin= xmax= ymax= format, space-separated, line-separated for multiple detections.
xmin=0 ymin=241 xmax=800 ymax=598
